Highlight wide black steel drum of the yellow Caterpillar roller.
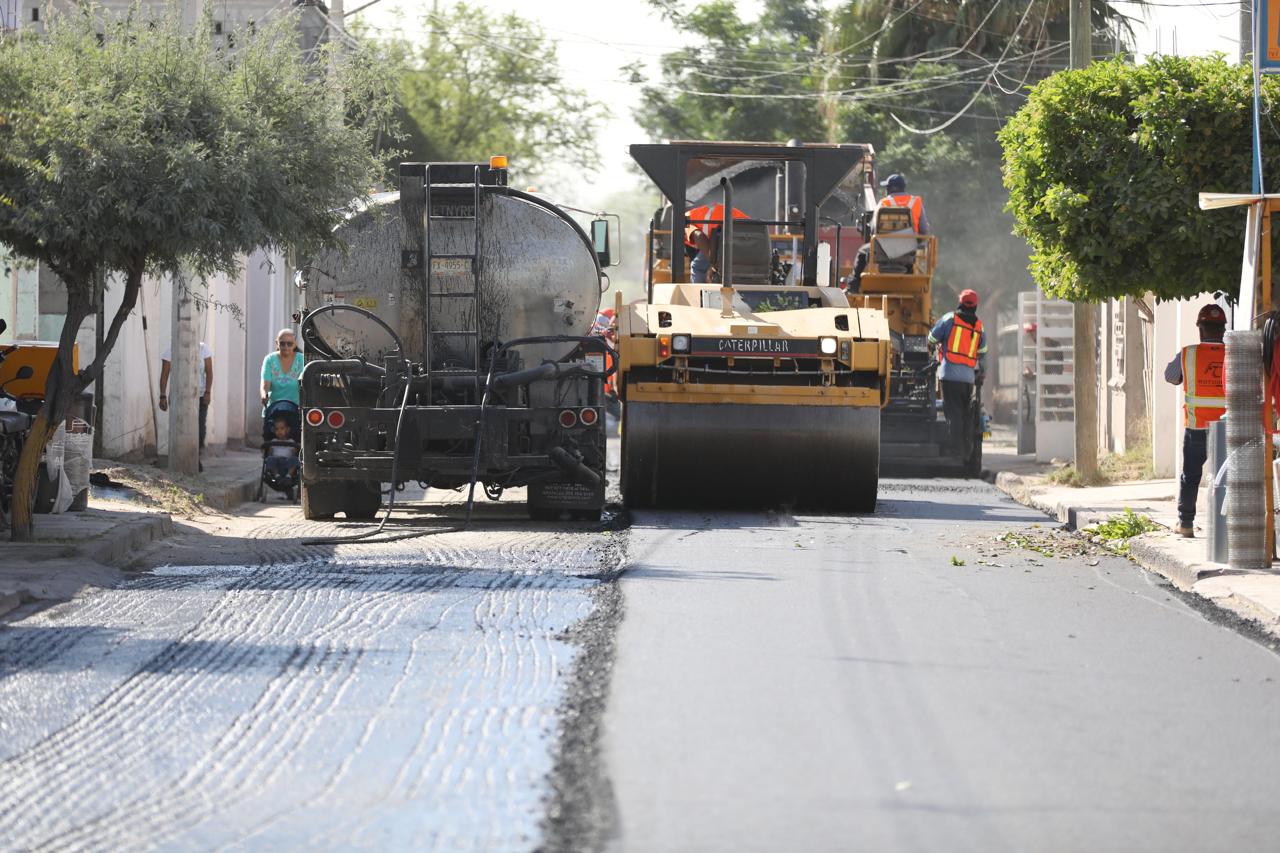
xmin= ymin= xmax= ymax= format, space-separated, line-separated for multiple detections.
xmin=622 ymin=401 xmax=879 ymax=512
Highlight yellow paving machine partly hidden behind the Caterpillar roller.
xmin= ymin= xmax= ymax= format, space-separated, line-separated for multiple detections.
xmin=849 ymin=192 xmax=983 ymax=476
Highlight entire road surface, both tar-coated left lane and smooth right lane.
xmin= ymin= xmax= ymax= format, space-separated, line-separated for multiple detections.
xmin=0 ymin=480 xmax=1280 ymax=850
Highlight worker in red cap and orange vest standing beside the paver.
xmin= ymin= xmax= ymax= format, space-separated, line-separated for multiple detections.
xmin=929 ymin=289 xmax=987 ymax=453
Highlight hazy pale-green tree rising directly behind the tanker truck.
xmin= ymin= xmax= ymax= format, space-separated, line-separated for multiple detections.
xmin=385 ymin=3 xmax=607 ymax=183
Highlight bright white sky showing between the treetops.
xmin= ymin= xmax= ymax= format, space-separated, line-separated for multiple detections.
xmin=360 ymin=0 xmax=1239 ymax=209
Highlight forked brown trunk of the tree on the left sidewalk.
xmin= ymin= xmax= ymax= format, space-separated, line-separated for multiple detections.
xmin=9 ymin=266 xmax=143 ymax=542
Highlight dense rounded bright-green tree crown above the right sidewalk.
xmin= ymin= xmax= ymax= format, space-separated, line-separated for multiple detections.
xmin=1000 ymin=56 xmax=1280 ymax=302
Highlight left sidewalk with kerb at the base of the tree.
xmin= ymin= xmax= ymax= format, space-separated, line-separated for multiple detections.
xmin=0 ymin=451 xmax=262 ymax=616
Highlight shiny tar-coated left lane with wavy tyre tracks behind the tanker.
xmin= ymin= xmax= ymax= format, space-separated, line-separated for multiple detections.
xmin=0 ymin=507 xmax=620 ymax=850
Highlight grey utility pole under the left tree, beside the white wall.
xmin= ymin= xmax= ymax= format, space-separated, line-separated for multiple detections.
xmin=166 ymin=0 xmax=200 ymax=474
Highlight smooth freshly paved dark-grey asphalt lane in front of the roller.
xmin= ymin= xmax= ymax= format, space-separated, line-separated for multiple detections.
xmin=604 ymin=480 xmax=1280 ymax=852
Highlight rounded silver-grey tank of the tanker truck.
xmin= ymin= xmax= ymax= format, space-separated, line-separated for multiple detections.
xmin=300 ymin=190 xmax=600 ymax=368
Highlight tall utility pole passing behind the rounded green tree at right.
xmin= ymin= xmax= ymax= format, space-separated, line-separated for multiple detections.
xmin=1069 ymin=0 xmax=1098 ymax=483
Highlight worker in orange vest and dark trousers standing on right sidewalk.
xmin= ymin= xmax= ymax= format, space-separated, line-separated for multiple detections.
xmin=1165 ymin=302 xmax=1226 ymax=537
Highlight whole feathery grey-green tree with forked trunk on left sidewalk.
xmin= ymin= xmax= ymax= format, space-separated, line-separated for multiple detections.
xmin=0 ymin=6 xmax=392 ymax=539
